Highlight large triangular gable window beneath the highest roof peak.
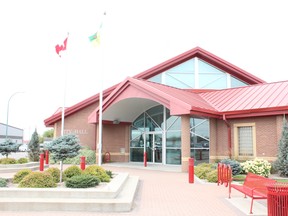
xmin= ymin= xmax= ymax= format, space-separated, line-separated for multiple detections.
xmin=149 ymin=58 xmax=247 ymax=89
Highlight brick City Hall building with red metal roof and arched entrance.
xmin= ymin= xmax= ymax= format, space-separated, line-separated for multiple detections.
xmin=44 ymin=47 xmax=288 ymax=171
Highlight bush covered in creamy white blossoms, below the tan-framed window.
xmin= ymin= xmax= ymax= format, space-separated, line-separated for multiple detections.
xmin=241 ymin=158 xmax=271 ymax=177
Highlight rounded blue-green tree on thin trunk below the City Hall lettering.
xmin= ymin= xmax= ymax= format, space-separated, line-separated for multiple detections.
xmin=46 ymin=134 xmax=81 ymax=182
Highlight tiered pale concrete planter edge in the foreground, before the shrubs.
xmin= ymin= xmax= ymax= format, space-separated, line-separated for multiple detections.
xmin=0 ymin=173 xmax=139 ymax=212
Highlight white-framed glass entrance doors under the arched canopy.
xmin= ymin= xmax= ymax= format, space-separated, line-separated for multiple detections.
xmin=145 ymin=133 xmax=162 ymax=163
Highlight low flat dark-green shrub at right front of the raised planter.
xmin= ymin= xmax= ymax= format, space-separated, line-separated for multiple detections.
xmin=65 ymin=175 xmax=100 ymax=188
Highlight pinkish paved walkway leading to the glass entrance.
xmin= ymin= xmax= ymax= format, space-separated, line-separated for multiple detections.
xmin=0 ymin=163 xmax=267 ymax=216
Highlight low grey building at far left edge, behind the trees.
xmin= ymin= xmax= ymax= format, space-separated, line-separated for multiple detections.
xmin=0 ymin=123 xmax=24 ymax=144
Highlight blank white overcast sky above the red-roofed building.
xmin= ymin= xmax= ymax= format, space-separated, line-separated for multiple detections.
xmin=0 ymin=0 xmax=288 ymax=139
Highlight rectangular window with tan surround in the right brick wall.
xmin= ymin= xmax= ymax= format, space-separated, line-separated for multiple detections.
xmin=234 ymin=123 xmax=256 ymax=158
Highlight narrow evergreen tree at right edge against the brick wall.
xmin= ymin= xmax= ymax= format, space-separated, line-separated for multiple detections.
xmin=275 ymin=117 xmax=288 ymax=176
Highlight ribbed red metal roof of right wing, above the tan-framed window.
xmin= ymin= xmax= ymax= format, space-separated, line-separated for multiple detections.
xmin=199 ymin=81 xmax=288 ymax=117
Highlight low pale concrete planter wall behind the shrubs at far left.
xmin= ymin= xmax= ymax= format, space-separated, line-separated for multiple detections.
xmin=0 ymin=162 xmax=49 ymax=173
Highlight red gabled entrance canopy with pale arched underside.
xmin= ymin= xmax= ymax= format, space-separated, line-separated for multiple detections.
xmin=88 ymin=77 xmax=217 ymax=123
